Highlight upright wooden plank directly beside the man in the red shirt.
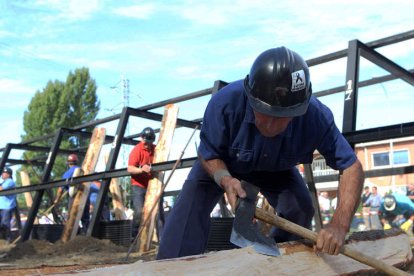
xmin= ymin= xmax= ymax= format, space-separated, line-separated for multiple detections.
xmin=139 ymin=104 xmax=178 ymax=252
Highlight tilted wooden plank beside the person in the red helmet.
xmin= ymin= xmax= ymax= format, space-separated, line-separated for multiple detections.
xmin=61 ymin=128 xmax=106 ymax=242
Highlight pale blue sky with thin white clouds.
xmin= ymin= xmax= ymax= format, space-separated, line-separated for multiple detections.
xmin=0 ymin=0 xmax=414 ymax=190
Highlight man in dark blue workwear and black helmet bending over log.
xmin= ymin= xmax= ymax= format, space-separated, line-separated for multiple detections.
xmin=157 ymin=47 xmax=364 ymax=259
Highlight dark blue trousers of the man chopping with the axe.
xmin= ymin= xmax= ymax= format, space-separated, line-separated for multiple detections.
xmin=157 ymin=161 xmax=314 ymax=259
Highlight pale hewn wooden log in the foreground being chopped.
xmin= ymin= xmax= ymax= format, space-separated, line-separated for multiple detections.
xmin=82 ymin=230 xmax=413 ymax=276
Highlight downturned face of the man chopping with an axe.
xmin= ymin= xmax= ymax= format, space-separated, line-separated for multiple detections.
xmin=253 ymin=111 xmax=292 ymax=138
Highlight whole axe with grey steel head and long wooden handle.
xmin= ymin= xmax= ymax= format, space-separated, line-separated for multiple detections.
xmin=230 ymin=181 xmax=409 ymax=275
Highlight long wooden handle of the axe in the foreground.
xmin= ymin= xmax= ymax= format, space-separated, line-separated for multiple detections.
xmin=255 ymin=208 xmax=409 ymax=275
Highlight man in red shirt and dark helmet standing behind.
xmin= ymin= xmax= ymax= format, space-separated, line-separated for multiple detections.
xmin=128 ymin=127 xmax=155 ymax=238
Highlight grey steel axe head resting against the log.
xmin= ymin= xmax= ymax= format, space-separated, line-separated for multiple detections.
xmin=230 ymin=181 xmax=280 ymax=256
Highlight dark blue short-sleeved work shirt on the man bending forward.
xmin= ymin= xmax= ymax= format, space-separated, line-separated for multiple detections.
xmin=199 ymin=80 xmax=356 ymax=174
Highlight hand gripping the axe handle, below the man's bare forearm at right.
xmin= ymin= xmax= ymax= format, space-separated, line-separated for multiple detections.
xmin=314 ymin=225 xmax=347 ymax=255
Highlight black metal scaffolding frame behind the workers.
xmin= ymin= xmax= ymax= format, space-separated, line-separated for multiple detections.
xmin=0 ymin=30 xmax=414 ymax=241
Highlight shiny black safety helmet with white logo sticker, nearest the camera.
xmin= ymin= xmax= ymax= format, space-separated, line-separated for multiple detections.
xmin=244 ymin=47 xmax=312 ymax=117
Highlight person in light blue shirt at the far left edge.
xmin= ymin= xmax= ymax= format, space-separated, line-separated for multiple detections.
xmin=0 ymin=167 xmax=17 ymax=242
